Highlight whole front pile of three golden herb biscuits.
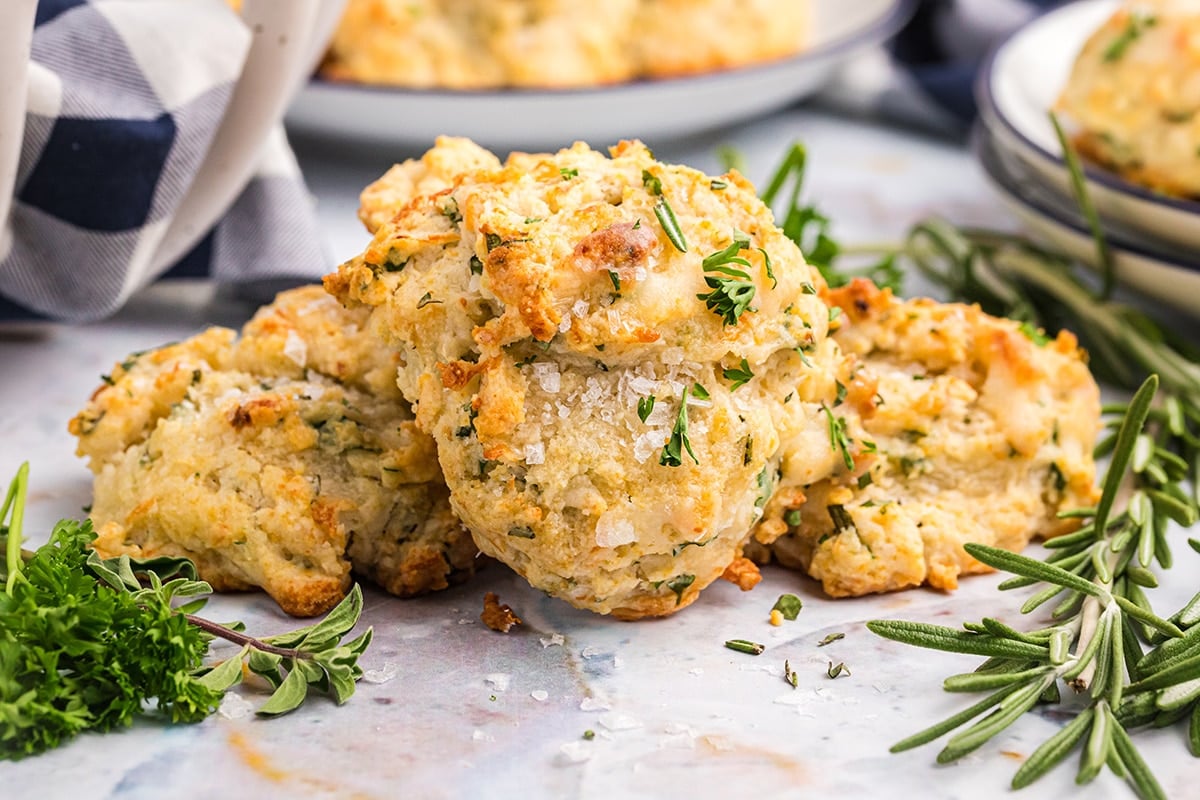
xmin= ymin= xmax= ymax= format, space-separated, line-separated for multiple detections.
xmin=71 ymin=138 xmax=1099 ymax=619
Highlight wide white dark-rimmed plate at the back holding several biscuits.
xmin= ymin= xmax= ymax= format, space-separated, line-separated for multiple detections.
xmin=287 ymin=0 xmax=913 ymax=151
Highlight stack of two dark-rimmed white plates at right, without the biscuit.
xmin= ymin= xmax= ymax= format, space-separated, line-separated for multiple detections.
xmin=974 ymin=0 xmax=1200 ymax=314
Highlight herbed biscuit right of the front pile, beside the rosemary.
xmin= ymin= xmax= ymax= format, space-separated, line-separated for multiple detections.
xmin=751 ymin=281 xmax=1099 ymax=597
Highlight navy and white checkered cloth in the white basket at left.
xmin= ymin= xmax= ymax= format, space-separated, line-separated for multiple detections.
xmin=0 ymin=0 xmax=328 ymax=321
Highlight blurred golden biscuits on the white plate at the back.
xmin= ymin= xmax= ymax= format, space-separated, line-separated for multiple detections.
xmin=320 ymin=0 xmax=811 ymax=89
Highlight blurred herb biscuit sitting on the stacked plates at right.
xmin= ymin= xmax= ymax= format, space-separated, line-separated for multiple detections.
xmin=1057 ymin=0 xmax=1200 ymax=197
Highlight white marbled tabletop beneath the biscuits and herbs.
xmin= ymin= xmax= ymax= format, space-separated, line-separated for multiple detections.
xmin=0 ymin=112 xmax=1200 ymax=800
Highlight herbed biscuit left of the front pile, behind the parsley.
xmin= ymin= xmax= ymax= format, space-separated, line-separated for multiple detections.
xmin=70 ymin=287 xmax=476 ymax=616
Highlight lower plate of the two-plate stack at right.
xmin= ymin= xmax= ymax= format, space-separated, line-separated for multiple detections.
xmin=974 ymin=127 xmax=1200 ymax=314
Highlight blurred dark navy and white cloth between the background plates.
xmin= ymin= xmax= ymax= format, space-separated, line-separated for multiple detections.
xmin=821 ymin=0 xmax=1063 ymax=137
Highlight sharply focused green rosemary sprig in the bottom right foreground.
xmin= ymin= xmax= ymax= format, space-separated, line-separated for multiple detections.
xmin=868 ymin=377 xmax=1200 ymax=798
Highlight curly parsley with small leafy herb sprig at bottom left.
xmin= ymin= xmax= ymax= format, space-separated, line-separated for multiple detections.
xmin=0 ymin=464 xmax=371 ymax=759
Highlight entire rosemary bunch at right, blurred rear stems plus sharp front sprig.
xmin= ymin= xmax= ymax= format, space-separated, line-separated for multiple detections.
xmin=763 ymin=130 xmax=1200 ymax=798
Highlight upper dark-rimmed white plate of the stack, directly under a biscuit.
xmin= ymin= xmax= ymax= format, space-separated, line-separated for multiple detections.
xmin=976 ymin=0 xmax=1200 ymax=249
